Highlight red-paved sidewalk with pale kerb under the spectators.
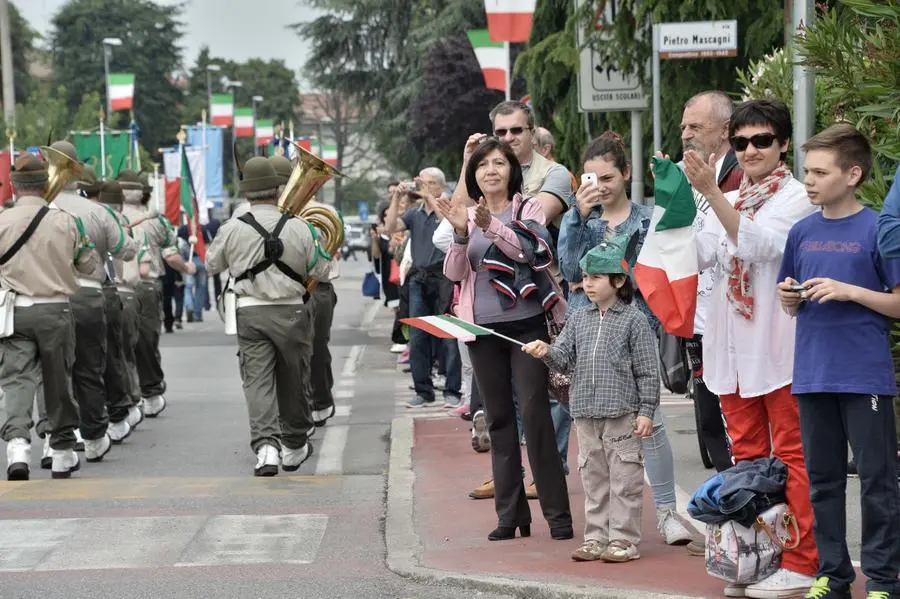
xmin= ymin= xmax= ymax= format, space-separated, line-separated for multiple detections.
xmin=386 ymin=413 xmax=865 ymax=599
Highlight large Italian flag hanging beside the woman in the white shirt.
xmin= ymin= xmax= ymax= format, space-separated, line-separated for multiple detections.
xmin=634 ymin=158 xmax=698 ymax=338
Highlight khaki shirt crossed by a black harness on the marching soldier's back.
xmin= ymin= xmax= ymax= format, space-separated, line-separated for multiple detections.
xmin=206 ymin=204 xmax=329 ymax=300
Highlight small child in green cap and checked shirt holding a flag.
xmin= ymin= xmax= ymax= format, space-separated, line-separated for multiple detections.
xmin=522 ymin=240 xmax=660 ymax=562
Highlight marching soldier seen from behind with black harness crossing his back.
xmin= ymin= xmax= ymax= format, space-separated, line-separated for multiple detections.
xmin=206 ymin=157 xmax=328 ymax=476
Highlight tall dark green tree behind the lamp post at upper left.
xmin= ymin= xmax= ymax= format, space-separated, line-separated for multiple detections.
xmin=51 ymin=0 xmax=182 ymax=149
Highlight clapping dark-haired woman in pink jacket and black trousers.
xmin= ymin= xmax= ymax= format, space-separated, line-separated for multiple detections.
xmin=438 ymin=136 xmax=573 ymax=541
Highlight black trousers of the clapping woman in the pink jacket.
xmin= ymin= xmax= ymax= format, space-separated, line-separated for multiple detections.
xmin=468 ymin=316 xmax=572 ymax=528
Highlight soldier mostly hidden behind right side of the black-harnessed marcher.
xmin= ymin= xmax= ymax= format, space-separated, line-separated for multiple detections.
xmin=269 ymin=156 xmax=340 ymax=426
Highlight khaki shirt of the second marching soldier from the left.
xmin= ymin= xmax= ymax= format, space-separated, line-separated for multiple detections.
xmin=51 ymin=190 xmax=138 ymax=283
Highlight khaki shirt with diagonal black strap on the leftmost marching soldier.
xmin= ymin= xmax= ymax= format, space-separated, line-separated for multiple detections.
xmin=0 ymin=196 xmax=98 ymax=297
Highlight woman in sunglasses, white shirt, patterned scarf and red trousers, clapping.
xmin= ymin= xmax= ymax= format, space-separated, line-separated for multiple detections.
xmin=684 ymin=100 xmax=818 ymax=598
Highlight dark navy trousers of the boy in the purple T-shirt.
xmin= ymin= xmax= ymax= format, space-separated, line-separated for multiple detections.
xmin=797 ymin=393 xmax=900 ymax=593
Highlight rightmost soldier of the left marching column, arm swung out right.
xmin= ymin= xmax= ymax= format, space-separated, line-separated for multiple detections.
xmin=118 ymin=170 xmax=196 ymax=418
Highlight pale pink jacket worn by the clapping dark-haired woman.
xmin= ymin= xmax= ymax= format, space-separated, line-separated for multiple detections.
xmin=444 ymin=194 xmax=566 ymax=326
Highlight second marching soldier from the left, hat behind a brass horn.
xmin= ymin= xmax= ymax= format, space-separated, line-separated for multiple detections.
xmin=50 ymin=141 xmax=137 ymax=462
